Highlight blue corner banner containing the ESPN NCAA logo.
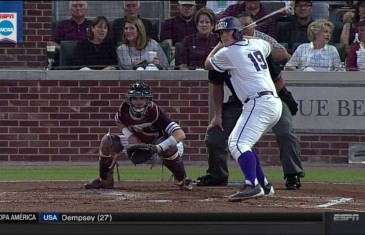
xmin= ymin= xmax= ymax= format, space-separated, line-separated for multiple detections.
xmin=0 ymin=1 xmax=23 ymax=44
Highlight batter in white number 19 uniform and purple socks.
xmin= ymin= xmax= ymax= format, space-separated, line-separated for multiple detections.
xmin=205 ymin=17 xmax=282 ymax=201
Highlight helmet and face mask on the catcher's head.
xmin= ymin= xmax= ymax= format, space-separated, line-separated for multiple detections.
xmin=126 ymin=82 xmax=153 ymax=118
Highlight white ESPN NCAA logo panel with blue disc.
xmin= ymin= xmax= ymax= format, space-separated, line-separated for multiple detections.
xmin=0 ymin=13 xmax=17 ymax=43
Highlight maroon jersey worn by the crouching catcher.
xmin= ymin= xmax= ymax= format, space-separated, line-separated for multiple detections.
xmin=115 ymin=102 xmax=181 ymax=144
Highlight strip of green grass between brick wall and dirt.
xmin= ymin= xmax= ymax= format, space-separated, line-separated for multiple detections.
xmin=0 ymin=165 xmax=365 ymax=184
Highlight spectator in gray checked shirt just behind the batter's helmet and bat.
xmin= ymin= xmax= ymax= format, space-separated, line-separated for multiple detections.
xmin=238 ymin=12 xmax=291 ymax=65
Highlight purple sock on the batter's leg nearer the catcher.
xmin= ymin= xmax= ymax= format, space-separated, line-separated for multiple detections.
xmin=237 ymin=151 xmax=256 ymax=186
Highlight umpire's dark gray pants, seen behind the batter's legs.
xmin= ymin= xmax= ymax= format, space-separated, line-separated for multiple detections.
xmin=205 ymin=101 xmax=303 ymax=179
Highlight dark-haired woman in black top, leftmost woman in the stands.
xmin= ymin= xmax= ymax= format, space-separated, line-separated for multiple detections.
xmin=73 ymin=16 xmax=118 ymax=70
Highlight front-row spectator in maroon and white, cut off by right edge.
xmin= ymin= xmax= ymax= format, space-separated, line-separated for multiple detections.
xmin=346 ymin=19 xmax=365 ymax=71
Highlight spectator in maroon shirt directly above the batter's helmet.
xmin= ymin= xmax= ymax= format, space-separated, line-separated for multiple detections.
xmin=216 ymin=1 xmax=277 ymax=39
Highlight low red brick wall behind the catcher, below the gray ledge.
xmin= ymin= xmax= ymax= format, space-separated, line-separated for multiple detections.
xmin=0 ymin=80 xmax=209 ymax=161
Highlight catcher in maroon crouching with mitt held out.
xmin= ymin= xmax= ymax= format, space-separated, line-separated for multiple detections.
xmin=84 ymin=81 xmax=192 ymax=190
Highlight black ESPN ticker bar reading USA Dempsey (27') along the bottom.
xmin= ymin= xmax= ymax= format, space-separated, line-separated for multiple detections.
xmin=0 ymin=211 xmax=365 ymax=235
